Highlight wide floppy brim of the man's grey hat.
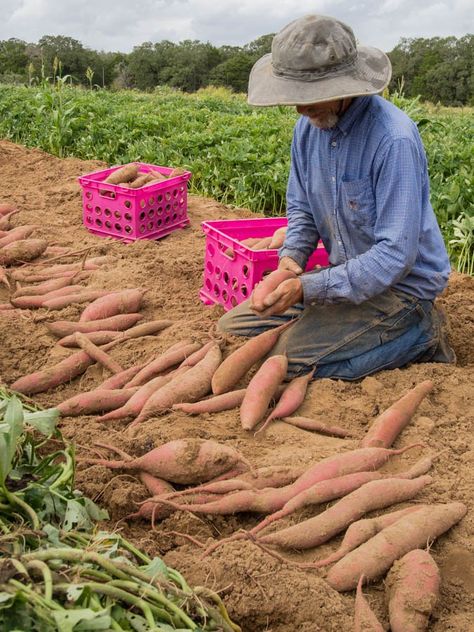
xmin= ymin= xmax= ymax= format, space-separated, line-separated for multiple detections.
xmin=247 ymin=46 xmax=392 ymax=106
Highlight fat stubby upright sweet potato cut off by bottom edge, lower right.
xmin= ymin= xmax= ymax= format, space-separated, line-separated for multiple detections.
xmin=385 ymin=549 xmax=441 ymax=632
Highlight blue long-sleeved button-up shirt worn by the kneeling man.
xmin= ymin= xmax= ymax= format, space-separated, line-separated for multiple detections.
xmin=279 ymin=96 xmax=450 ymax=304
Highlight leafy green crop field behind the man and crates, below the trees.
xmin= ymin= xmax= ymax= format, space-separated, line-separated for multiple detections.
xmin=0 ymin=77 xmax=474 ymax=274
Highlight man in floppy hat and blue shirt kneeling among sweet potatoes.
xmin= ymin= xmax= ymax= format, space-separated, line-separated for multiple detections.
xmin=219 ymin=15 xmax=455 ymax=380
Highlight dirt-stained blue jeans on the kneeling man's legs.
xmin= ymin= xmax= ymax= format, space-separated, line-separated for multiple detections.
xmin=218 ymin=290 xmax=447 ymax=380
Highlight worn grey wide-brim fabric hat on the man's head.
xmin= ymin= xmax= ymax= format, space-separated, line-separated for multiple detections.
xmin=248 ymin=15 xmax=392 ymax=106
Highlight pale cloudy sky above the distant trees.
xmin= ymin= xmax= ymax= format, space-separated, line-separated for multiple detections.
xmin=0 ymin=0 xmax=474 ymax=53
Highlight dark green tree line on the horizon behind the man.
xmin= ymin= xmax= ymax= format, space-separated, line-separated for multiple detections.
xmin=0 ymin=33 xmax=474 ymax=106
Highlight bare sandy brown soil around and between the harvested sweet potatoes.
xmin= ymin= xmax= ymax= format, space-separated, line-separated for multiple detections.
xmin=0 ymin=141 xmax=474 ymax=632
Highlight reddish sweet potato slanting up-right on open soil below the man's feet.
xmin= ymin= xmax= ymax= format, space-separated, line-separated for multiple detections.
xmin=361 ymin=380 xmax=434 ymax=448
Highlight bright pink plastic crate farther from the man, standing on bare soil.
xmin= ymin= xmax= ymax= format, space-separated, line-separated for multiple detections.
xmin=78 ymin=162 xmax=191 ymax=242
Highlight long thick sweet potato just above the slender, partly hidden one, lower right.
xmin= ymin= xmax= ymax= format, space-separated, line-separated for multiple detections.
xmin=259 ymin=476 xmax=432 ymax=550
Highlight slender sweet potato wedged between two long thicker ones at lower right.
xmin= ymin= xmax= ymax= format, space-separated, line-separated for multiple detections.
xmin=307 ymin=505 xmax=427 ymax=568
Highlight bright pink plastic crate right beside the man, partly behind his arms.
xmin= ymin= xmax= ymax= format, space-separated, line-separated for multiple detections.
xmin=199 ymin=217 xmax=329 ymax=311
